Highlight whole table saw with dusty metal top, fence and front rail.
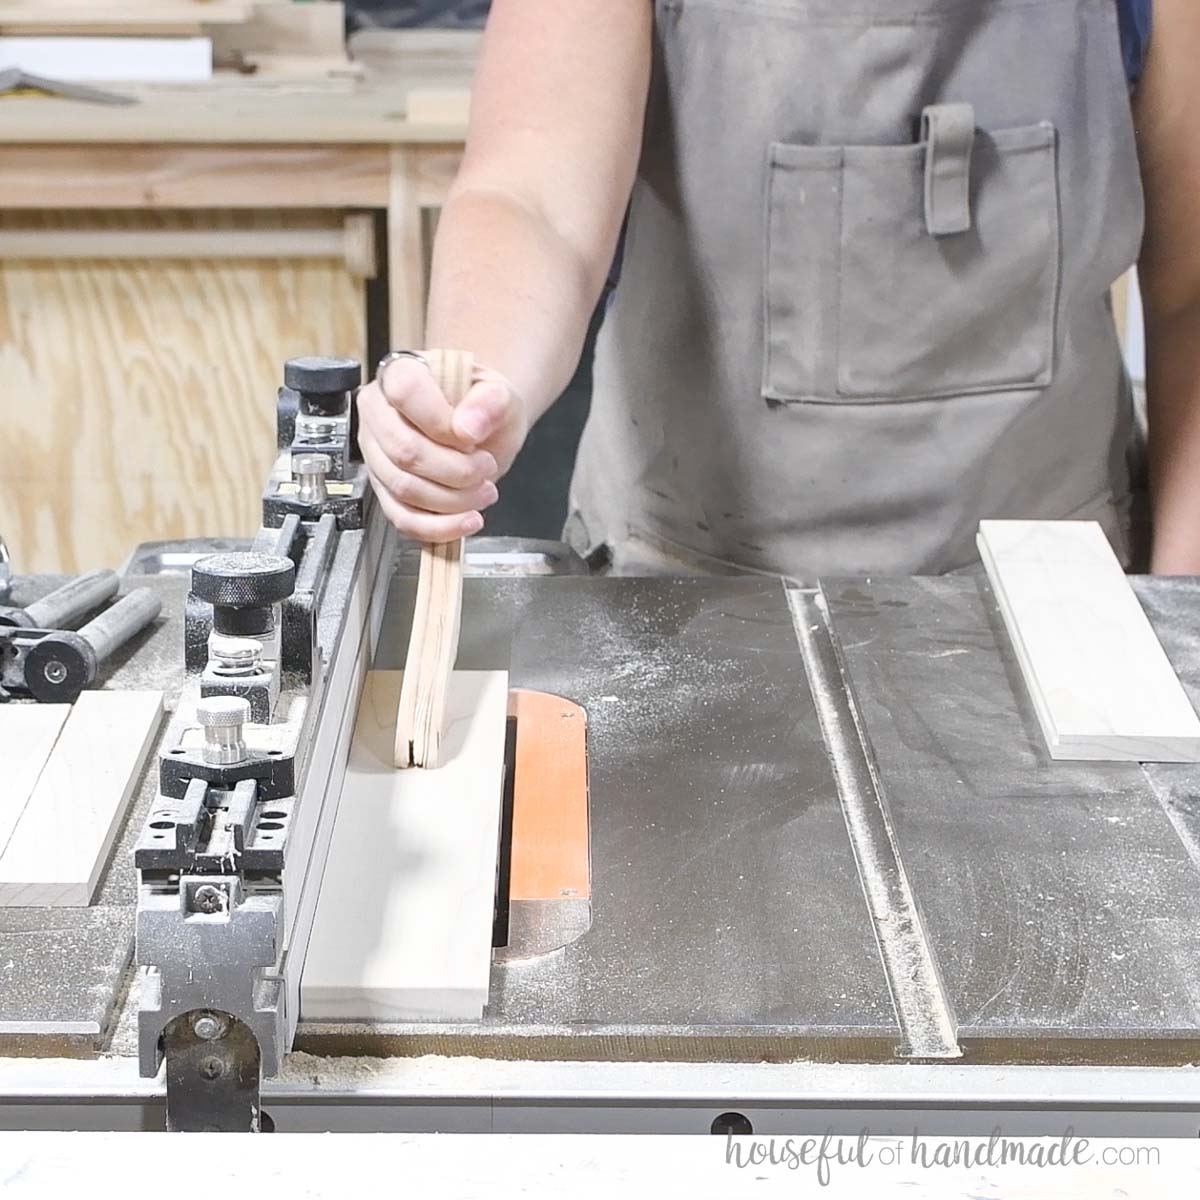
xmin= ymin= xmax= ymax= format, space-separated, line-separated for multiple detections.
xmin=0 ymin=360 xmax=1200 ymax=1136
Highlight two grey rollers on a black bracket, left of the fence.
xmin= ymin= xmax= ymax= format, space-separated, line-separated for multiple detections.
xmin=0 ymin=570 xmax=162 ymax=704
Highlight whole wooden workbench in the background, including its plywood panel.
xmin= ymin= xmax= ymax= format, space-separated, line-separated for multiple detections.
xmin=0 ymin=77 xmax=466 ymax=570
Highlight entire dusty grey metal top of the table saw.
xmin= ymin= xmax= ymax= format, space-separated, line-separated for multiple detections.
xmin=0 ymin=556 xmax=1200 ymax=1064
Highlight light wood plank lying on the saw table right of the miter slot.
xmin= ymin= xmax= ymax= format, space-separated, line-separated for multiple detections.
xmin=978 ymin=521 xmax=1200 ymax=762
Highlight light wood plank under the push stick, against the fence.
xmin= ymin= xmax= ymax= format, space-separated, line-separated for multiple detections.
xmin=300 ymin=671 xmax=508 ymax=1021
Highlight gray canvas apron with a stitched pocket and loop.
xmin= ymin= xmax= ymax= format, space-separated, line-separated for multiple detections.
xmin=566 ymin=0 xmax=1142 ymax=577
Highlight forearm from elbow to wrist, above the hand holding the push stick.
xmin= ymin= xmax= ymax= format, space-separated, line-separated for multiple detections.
xmin=426 ymin=177 xmax=604 ymax=424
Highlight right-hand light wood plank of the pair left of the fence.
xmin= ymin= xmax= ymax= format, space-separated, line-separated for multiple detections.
xmin=0 ymin=691 xmax=162 ymax=907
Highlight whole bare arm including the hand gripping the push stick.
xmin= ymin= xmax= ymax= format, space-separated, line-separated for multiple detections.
xmin=358 ymin=0 xmax=652 ymax=541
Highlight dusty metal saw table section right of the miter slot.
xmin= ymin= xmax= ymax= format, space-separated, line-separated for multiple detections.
xmin=823 ymin=578 xmax=1200 ymax=1058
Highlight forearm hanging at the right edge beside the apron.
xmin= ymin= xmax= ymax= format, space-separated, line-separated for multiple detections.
xmin=1146 ymin=299 xmax=1200 ymax=575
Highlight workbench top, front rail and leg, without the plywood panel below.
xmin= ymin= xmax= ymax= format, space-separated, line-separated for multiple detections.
xmin=0 ymin=79 xmax=467 ymax=346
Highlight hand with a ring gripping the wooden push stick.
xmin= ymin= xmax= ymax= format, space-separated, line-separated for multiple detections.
xmin=358 ymin=359 xmax=528 ymax=541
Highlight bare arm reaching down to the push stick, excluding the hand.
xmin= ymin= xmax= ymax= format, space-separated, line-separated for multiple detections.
xmin=427 ymin=0 xmax=652 ymax=424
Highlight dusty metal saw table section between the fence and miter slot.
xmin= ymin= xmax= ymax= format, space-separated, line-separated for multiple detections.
xmin=298 ymin=578 xmax=899 ymax=1060
